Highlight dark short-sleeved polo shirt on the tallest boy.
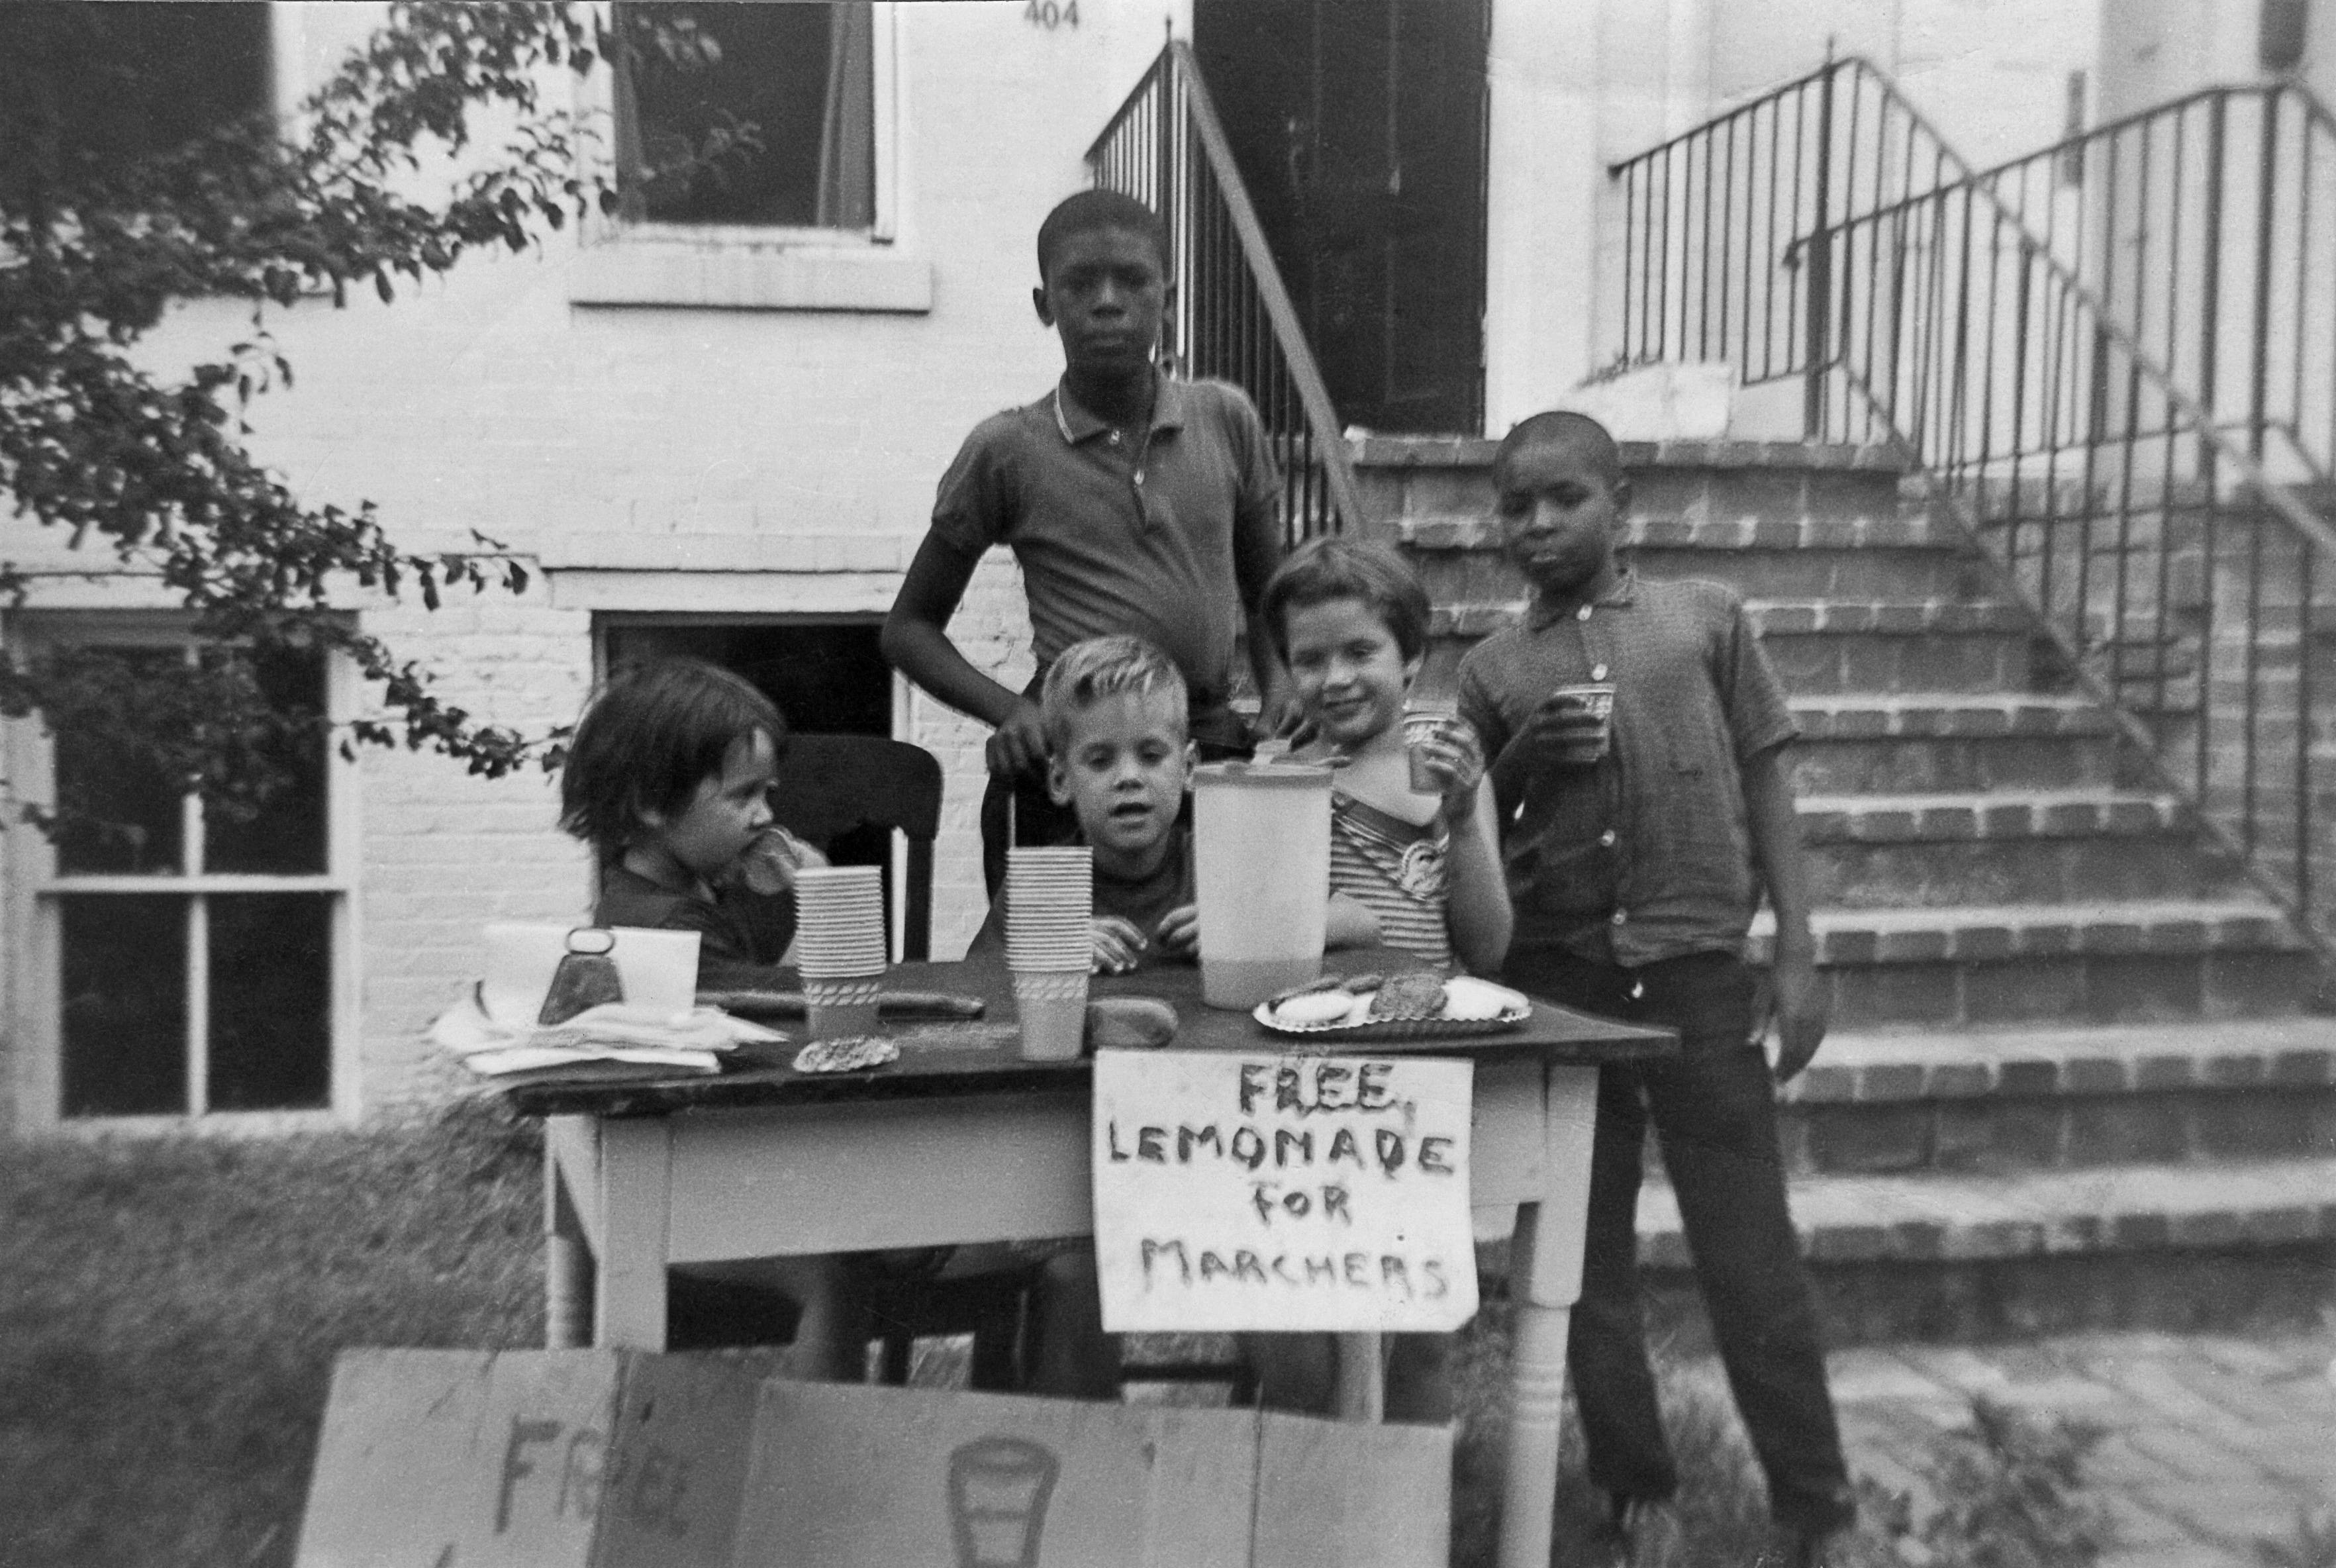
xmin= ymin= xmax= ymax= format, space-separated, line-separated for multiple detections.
xmin=932 ymin=376 xmax=1280 ymax=706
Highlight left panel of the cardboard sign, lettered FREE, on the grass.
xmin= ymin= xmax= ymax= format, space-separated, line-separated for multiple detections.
xmin=297 ymin=1351 xmax=759 ymax=1568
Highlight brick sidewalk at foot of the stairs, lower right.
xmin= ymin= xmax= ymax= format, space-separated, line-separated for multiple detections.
xmin=1831 ymin=1334 xmax=2336 ymax=1568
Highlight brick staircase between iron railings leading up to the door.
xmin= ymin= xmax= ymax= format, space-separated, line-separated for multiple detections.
xmin=1355 ymin=437 xmax=2336 ymax=1342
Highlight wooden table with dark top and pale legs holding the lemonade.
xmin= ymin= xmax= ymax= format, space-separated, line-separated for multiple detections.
xmin=507 ymin=954 xmax=1677 ymax=1568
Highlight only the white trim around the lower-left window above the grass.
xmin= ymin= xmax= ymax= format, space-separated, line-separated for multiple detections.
xmin=0 ymin=610 xmax=364 ymax=1134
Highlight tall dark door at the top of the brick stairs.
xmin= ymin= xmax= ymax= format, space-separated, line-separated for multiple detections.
xmin=1194 ymin=0 xmax=1486 ymax=434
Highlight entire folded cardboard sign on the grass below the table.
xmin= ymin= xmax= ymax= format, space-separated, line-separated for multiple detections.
xmin=297 ymin=1351 xmax=1451 ymax=1568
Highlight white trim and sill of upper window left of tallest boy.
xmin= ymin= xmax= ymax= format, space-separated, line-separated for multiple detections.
xmin=567 ymin=0 xmax=932 ymax=313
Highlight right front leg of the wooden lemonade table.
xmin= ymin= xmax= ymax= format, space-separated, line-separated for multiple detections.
xmin=1500 ymin=1065 xmax=1598 ymax=1568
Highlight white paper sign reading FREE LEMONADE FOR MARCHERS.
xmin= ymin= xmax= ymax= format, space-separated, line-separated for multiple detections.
xmin=1093 ymin=1052 xmax=1477 ymax=1332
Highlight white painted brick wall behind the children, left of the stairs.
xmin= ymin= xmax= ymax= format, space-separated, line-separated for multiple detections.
xmin=0 ymin=0 xmax=1168 ymax=1131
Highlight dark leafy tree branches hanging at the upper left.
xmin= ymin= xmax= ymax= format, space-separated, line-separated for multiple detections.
xmin=0 ymin=0 xmax=738 ymax=827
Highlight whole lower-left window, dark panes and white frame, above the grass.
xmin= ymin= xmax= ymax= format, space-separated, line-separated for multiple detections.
xmin=9 ymin=619 xmax=353 ymax=1122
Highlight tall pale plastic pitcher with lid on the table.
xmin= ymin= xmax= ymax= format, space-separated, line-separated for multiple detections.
xmin=1191 ymin=761 xmax=1332 ymax=1007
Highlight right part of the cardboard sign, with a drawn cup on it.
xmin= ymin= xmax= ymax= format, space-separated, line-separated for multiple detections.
xmin=738 ymin=1379 xmax=1451 ymax=1568
